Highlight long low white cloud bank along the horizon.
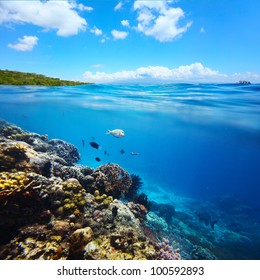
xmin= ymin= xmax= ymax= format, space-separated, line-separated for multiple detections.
xmin=84 ymin=62 xmax=227 ymax=83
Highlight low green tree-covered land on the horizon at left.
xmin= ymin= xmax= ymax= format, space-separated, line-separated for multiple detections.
xmin=0 ymin=70 xmax=89 ymax=86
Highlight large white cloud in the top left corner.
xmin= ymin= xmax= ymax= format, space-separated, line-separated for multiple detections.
xmin=0 ymin=0 xmax=87 ymax=37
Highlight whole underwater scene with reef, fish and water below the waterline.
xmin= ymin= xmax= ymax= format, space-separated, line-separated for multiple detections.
xmin=0 ymin=84 xmax=260 ymax=260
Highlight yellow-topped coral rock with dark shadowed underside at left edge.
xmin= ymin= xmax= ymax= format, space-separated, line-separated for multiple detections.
xmin=0 ymin=171 xmax=49 ymax=231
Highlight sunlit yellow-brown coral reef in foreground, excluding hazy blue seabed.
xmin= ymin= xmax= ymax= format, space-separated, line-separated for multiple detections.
xmin=0 ymin=120 xmax=179 ymax=260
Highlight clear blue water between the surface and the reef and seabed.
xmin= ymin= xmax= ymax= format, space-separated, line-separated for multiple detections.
xmin=0 ymin=84 xmax=260 ymax=207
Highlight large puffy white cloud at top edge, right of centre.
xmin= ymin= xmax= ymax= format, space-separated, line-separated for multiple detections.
xmin=134 ymin=0 xmax=191 ymax=42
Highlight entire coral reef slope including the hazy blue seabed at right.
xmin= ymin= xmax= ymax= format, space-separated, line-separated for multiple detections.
xmin=0 ymin=119 xmax=260 ymax=260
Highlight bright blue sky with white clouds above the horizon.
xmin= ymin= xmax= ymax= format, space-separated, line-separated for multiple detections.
xmin=0 ymin=0 xmax=260 ymax=83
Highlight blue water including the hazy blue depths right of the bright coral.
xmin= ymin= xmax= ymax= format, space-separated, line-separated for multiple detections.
xmin=0 ymin=84 xmax=260 ymax=259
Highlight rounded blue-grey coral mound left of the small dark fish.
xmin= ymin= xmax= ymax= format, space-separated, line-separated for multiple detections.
xmin=48 ymin=139 xmax=80 ymax=165
